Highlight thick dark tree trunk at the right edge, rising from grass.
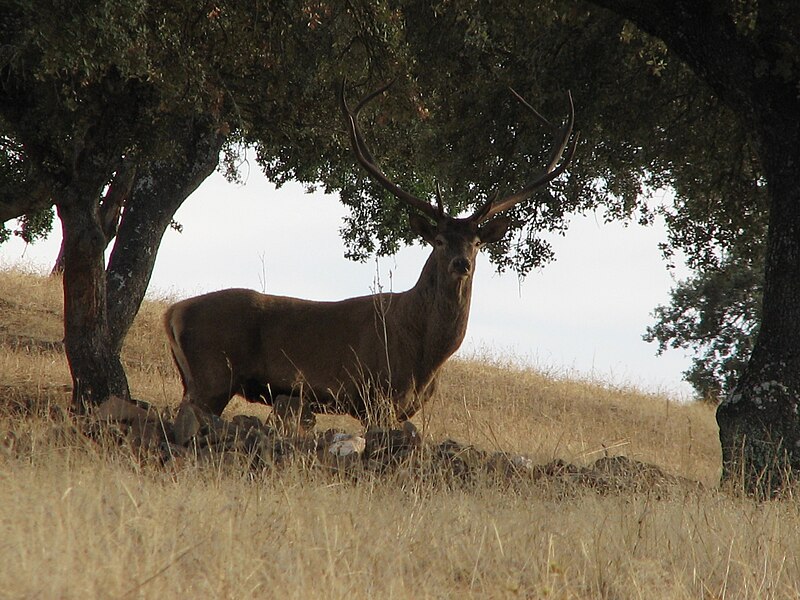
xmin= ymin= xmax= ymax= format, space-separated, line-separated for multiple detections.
xmin=717 ymin=96 xmax=800 ymax=494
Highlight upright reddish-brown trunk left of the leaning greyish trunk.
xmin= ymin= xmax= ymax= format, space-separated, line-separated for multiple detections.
xmin=57 ymin=195 xmax=130 ymax=412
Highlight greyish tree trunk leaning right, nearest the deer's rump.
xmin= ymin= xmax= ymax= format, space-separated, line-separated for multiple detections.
xmin=107 ymin=124 xmax=224 ymax=354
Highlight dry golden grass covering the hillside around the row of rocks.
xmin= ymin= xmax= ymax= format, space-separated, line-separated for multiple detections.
xmin=0 ymin=271 xmax=800 ymax=599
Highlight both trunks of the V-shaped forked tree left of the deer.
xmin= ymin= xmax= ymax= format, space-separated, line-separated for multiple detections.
xmin=57 ymin=122 xmax=224 ymax=412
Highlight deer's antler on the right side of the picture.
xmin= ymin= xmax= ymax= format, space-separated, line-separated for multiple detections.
xmin=469 ymin=88 xmax=579 ymax=223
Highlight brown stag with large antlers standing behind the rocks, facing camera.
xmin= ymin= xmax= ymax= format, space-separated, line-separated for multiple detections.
xmin=164 ymin=81 xmax=578 ymax=427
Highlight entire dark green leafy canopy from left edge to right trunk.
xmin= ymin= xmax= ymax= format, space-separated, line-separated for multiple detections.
xmin=0 ymin=0 xmax=780 ymax=394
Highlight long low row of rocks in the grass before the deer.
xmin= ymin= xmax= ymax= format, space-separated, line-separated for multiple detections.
xmin=37 ymin=398 xmax=699 ymax=494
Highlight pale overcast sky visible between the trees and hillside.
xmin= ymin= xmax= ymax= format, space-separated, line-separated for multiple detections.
xmin=0 ymin=169 xmax=691 ymax=399
